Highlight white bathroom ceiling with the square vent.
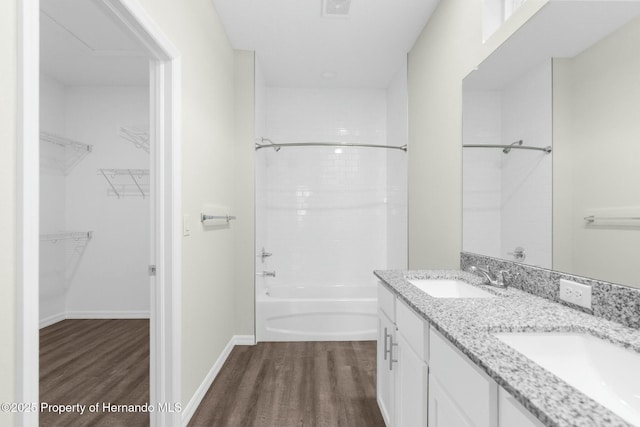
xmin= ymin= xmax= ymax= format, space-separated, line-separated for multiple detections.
xmin=212 ymin=0 xmax=438 ymax=88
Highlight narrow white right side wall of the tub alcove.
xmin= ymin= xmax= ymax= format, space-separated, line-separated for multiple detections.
xmin=385 ymin=62 xmax=409 ymax=269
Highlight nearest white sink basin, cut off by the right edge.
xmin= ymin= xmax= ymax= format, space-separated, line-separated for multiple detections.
xmin=494 ymin=332 xmax=640 ymax=425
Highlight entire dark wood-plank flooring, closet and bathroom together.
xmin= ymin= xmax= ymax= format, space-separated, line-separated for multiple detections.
xmin=40 ymin=320 xmax=384 ymax=427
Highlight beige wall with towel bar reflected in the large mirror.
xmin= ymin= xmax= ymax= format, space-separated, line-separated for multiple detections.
xmin=553 ymin=19 xmax=640 ymax=287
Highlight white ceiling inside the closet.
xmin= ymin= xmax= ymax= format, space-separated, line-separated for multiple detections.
xmin=40 ymin=0 xmax=149 ymax=86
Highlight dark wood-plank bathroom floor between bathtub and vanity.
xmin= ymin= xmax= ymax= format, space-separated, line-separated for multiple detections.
xmin=189 ymin=341 xmax=384 ymax=427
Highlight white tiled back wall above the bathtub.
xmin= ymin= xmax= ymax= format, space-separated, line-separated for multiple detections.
xmin=259 ymin=88 xmax=392 ymax=286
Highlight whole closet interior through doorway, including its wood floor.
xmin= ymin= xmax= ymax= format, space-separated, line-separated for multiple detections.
xmin=39 ymin=0 xmax=153 ymax=426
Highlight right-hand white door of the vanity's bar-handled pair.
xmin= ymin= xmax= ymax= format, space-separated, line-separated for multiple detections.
xmin=393 ymin=330 xmax=427 ymax=427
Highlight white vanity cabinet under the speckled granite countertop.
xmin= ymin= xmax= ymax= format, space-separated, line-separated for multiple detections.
xmin=377 ymin=284 xmax=543 ymax=427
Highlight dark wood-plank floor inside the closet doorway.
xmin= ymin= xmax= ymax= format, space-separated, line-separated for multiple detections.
xmin=40 ymin=319 xmax=149 ymax=427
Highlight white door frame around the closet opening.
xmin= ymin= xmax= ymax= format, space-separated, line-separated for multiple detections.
xmin=15 ymin=0 xmax=182 ymax=427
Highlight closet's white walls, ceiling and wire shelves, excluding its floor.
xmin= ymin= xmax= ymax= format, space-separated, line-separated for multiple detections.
xmin=40 ymin=0 xmax=151 ymax=327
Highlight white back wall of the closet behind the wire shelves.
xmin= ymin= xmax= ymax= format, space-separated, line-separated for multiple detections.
xmin=66 ymin=87 xmax=151 ymax=317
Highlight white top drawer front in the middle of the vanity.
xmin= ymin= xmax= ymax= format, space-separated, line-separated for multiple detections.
xmin=429 ymin=328 xmax=498 ymax=427
